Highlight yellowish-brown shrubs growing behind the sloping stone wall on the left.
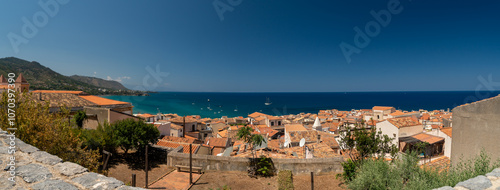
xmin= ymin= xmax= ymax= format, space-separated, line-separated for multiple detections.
xmin=0 ymin=92 xmax=101 ymax=172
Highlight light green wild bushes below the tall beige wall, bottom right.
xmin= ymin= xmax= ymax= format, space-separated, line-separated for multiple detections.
xmin=348 ymin=151 xmax=500 ymax=189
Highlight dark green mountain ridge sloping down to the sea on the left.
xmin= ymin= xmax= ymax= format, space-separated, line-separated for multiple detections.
xmin=0 ymin=57 xmax=139 ymax=95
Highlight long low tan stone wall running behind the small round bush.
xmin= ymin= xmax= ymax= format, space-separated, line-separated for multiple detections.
xmin=167 ymin=147 xmax=343 ymax=175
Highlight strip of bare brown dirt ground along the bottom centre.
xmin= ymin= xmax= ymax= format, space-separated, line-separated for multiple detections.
xmin=190 ymin=171 xmax=344 ymax=190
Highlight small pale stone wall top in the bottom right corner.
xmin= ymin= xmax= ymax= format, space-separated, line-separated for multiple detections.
xmin=437 ymin=168 xmax=500 ymax=190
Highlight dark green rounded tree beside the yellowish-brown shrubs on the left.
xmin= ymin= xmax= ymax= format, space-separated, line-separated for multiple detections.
xmin=112 ymin=118 xmax=160 ymax=153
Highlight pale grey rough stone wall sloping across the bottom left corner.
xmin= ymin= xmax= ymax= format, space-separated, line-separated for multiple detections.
xmin=0 ymin=130 xmax=142 ymax=190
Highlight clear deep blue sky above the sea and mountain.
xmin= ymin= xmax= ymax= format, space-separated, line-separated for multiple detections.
xmin=0 ymin=0 xmax=500 ymax=92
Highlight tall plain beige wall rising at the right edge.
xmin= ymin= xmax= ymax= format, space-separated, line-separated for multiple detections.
xmin=451 ymin=96 xmax=500 ymax=164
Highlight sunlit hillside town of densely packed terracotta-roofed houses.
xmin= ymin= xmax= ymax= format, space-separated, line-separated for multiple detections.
xmin=0 ymin=74 xmax=453 ymax=167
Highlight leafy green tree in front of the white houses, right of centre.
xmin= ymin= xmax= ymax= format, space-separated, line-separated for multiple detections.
xmin=337 ymin=122 xmax=398 ymax=182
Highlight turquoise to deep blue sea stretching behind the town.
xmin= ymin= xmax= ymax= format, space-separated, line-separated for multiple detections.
xmin=105 ymin=91 xmax=500 ymax=118
